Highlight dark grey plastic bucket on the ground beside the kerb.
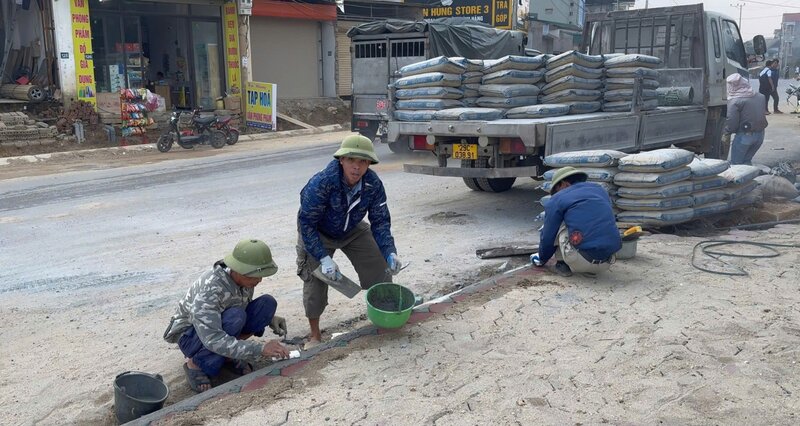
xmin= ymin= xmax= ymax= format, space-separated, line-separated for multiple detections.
xmin=114 ymin=371 xmax=169 ymax=424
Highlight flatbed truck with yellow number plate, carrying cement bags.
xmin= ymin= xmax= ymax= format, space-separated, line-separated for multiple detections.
xmin=387 ymin=4 xmax=766 ymax=192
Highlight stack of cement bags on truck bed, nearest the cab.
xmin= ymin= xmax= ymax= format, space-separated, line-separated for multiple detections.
xmin=603 ymin=54 xmax=661 ymax=112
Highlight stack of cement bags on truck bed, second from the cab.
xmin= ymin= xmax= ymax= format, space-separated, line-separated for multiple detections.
xmin=541 ymin=50 xmax=603 ymax=114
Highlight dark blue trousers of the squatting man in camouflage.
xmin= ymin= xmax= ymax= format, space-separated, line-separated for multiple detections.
xmin=178 ymin=294 xmax=278 ymax=376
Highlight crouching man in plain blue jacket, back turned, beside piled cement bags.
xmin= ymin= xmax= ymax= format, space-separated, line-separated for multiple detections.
xmin=531 ymin=167 xmax=622 ymax=276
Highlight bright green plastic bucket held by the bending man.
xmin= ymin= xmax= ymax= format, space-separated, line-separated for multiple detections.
xmin=366 ymin=283 xmax=415 ymax=328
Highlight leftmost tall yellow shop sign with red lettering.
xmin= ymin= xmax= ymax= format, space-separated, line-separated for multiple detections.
xmin=69 ymin=0 xmax=97 ymax=107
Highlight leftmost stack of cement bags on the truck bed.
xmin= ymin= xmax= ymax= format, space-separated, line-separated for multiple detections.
xmin=394 ymin=56 xmax=467 ymax=121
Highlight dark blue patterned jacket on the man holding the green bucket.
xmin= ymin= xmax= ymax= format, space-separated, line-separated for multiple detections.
xmin=297 ymin=160 xmax=397 ymax=260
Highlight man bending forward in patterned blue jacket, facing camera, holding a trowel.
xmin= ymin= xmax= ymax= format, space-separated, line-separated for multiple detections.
xmin=297 ymin=135 xmax=401 ymax=349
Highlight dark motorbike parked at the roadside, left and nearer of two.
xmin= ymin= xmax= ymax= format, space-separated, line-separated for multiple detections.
xmin=156 ymin=109 xmax=227 ymax=152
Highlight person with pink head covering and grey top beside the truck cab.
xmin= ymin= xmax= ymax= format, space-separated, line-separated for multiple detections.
xmin=725 ymin=73 xmax=768 ymax=165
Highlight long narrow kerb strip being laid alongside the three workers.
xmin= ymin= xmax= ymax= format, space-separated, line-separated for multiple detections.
xmin=126 ymin=265 xmax=545 ymax=426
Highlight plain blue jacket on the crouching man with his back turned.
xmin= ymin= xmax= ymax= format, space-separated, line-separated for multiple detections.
xmin=539 ymin=182 xmax=622 ymax=262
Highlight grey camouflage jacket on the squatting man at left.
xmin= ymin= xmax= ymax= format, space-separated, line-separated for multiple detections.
xmin=164 ymin=261 xmax=263 ymax=361
